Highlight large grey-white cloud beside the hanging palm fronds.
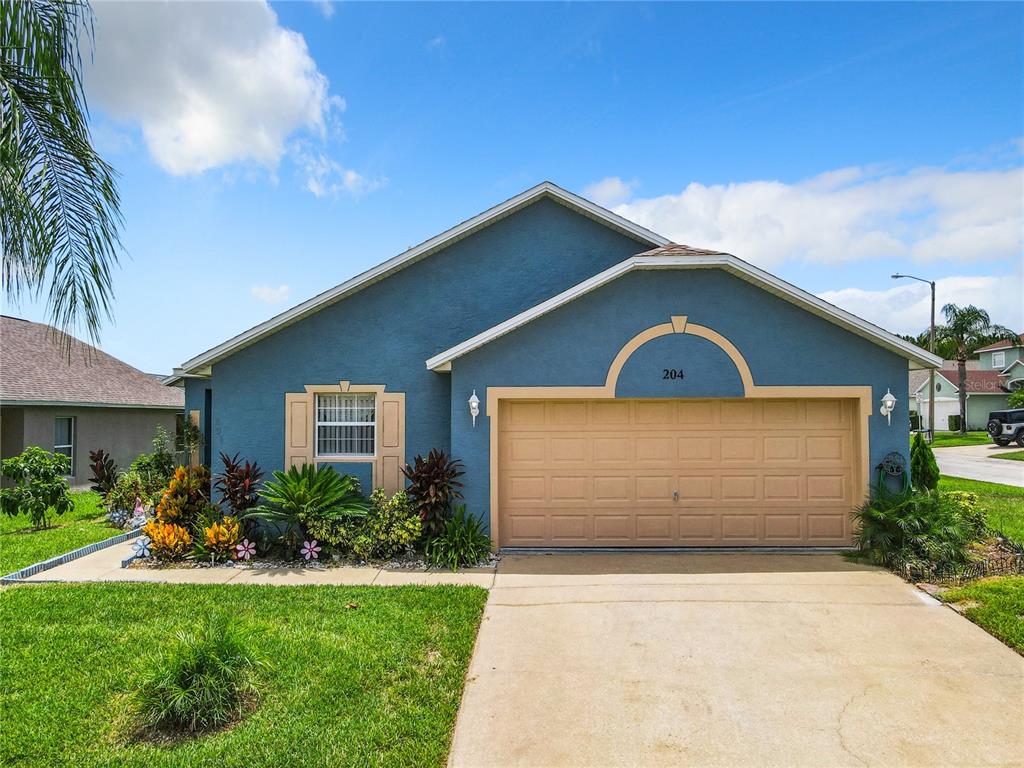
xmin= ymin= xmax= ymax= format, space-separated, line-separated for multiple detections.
xmin=86 ymin=0 xmax=340 ymax=175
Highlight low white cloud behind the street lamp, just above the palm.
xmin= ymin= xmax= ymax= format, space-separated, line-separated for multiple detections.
xmin=818 ymin=273 xmax=1024 ymax=334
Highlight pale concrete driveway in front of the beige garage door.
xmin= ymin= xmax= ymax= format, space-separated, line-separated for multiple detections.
xmin=450 ymin=553 xmax=1024 ymax=768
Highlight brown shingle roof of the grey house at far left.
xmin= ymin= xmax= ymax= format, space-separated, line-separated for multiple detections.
xmin=0 ymin=315 xmax=185 ymax=411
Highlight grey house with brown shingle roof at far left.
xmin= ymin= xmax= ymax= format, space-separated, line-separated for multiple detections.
xmin=0 ymin=315 xmax=184 ymax=486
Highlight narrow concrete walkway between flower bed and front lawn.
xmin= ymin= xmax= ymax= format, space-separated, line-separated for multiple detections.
xmin=18 ymin=542 xmax=495 ymax=588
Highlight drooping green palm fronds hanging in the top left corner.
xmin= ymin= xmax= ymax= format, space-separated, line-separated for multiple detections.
xmin=0 ymin=0 xmax=122 ymax=351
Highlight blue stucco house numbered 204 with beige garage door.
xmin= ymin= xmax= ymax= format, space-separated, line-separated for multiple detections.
xmin=168 ymin=182 xmax=941 ymax=547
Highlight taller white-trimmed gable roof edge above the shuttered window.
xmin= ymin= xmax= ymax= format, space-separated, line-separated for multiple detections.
xmin=164 ymin=181 xmax=669 ymax=384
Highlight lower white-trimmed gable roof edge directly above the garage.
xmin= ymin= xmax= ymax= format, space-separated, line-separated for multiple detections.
xmin=427 ymin=243 xmax=942 ymax=371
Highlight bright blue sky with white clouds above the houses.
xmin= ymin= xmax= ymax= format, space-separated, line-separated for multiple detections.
xmin=5 ymin=3 xmax=1024 ymax=372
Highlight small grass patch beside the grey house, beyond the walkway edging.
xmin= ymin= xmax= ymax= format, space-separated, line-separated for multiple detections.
xmin=0 ymin=490 xmax=121 ymax=574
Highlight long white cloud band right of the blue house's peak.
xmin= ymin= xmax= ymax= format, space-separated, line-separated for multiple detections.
xmin=606 ymin=167 xmax=1024 ymax=267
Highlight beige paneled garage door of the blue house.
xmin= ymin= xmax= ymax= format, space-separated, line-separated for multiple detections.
xmin=498 ymin=399 xmax=856 ymax=547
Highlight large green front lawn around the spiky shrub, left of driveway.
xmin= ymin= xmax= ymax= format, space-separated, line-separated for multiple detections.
xmin=0 ymin=584 xmax=486 ymax=768
